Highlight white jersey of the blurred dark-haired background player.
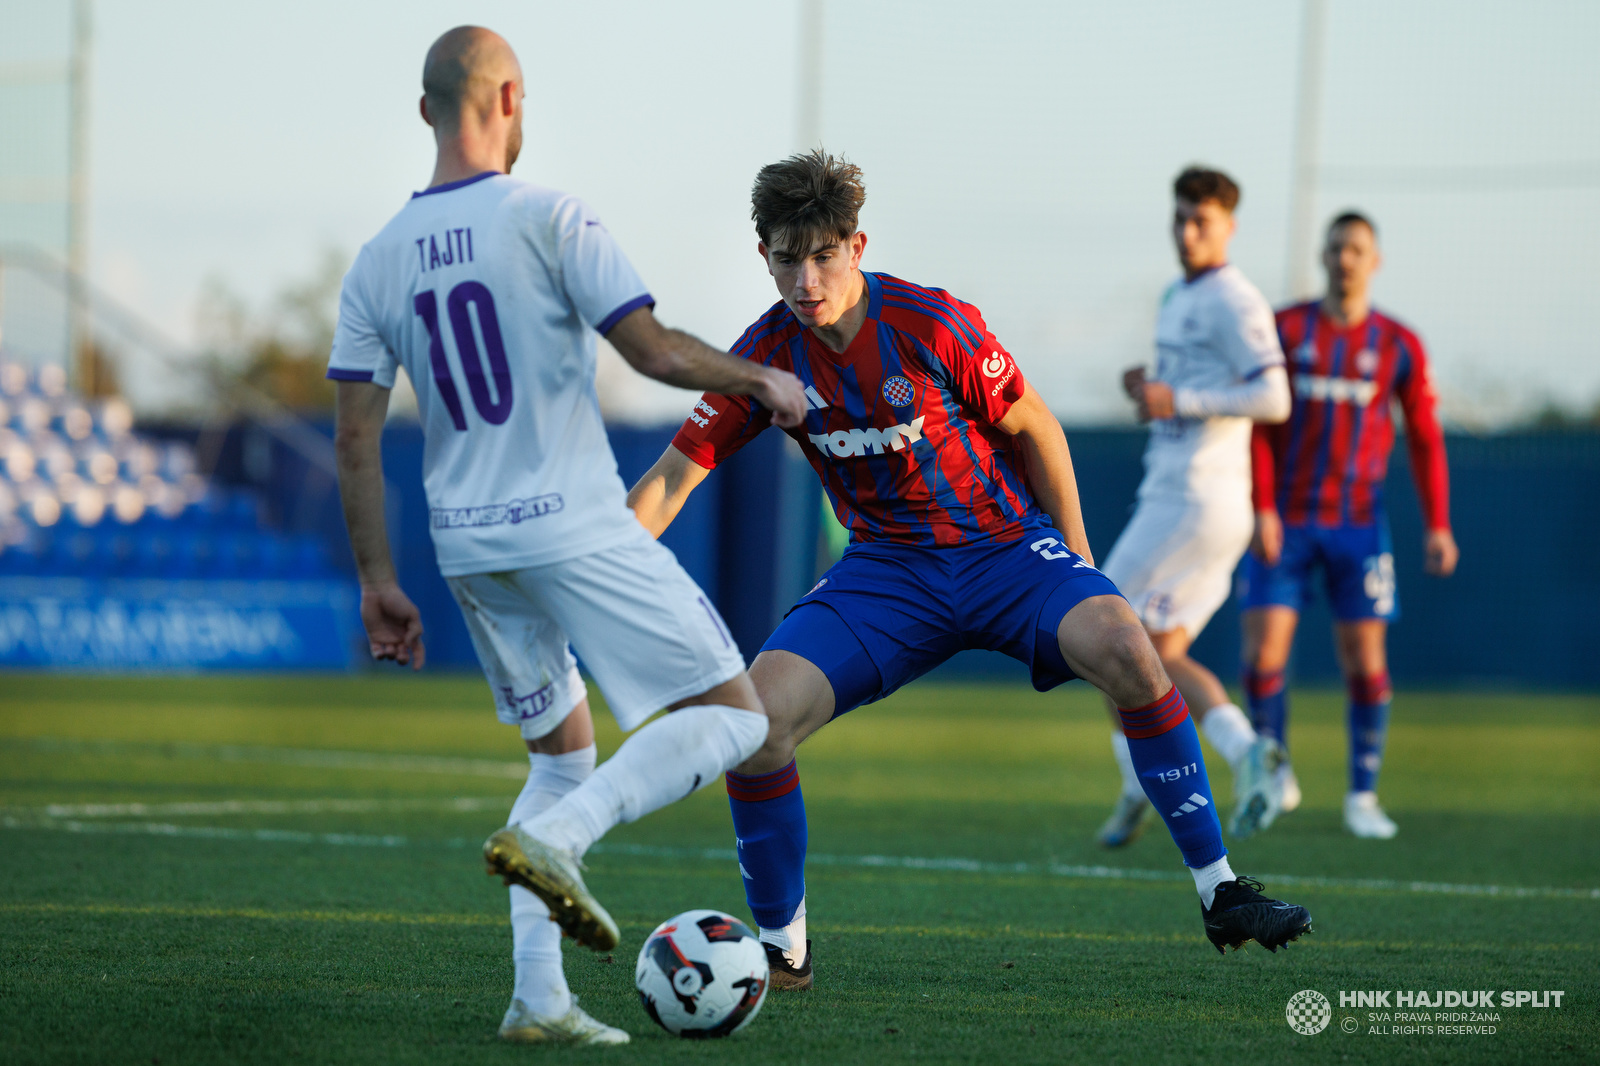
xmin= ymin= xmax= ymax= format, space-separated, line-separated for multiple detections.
xmin=1139 ymin=264 xmax=1283 ymax=507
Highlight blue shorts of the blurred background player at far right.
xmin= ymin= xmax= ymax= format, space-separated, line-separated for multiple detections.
xmin=1238 ymin=517 xmax=1400 ymax=623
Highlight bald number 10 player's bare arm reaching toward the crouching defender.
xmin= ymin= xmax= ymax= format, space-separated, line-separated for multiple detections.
xmin=606 ymin=307 xmax=806 ymax=429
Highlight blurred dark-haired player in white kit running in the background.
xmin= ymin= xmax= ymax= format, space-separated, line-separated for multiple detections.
xmin=1099 ymin=166 xmax=1291 ymax=847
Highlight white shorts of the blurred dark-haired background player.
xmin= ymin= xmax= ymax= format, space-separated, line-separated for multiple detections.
xmin=1101 ymin=496 xmax=1256 ymax=639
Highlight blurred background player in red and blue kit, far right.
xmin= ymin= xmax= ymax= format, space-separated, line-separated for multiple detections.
xmin=1242 ymin=211 xmax=1459 ymax=839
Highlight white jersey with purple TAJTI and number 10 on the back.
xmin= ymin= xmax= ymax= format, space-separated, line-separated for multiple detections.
xmin=328 ymin=173 xmax=654 ymax=576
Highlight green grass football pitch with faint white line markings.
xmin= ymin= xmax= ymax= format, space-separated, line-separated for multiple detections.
xmin=0 ymin=672 xmax=1600 ymax=1066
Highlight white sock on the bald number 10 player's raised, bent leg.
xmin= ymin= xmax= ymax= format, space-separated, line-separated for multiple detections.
xmin=522 ymin=703 xmax=766 ymax=856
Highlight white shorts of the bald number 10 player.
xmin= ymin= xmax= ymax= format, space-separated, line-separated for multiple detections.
xmin=445 ymin=527 xmax=744 ymax=739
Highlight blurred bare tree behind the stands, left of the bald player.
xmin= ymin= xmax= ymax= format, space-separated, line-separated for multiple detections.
xmin=197 ymin=248 xmax=350 ymax=413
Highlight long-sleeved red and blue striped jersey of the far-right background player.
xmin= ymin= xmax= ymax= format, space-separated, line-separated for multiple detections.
xmin=1251 ymin=303 xmax=1450 ymax=530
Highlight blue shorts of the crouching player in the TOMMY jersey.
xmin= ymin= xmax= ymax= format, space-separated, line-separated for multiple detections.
xmin=762 ymin=527 xmax=1122 ymax=717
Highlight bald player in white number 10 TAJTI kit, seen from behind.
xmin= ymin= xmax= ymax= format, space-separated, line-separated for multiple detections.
xmin=328 ymin=27 xmax=805 ymax=1044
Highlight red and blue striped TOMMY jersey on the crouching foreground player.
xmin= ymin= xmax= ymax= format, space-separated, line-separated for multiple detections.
xmin=672 ymin=274 xmax=1050 ymax=547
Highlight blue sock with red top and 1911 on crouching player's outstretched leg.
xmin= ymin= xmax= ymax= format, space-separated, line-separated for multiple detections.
xmin=1117 ymin=685 xmax=1227 ymax=868
